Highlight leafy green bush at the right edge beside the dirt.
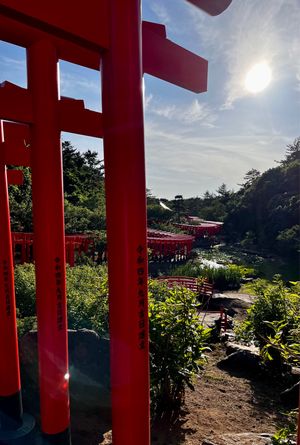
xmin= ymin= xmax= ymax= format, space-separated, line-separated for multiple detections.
xmin=236 ymin=276 xmax=300 ymax=367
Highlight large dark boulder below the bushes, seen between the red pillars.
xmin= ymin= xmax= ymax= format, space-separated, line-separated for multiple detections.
xmin=20 ymin=329 xmax=110 ymax=414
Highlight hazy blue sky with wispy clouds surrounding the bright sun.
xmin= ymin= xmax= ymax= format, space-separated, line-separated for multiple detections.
xmin=0 ymin=0 xmax=300 ymax=198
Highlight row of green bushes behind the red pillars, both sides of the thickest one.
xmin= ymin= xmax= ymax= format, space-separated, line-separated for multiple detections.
xmin=15 ymin=264 xmax=210 ymax=413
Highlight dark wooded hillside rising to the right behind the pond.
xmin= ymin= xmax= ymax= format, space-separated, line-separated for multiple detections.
xmin=148 ymin=138 xmax=300 ymax=257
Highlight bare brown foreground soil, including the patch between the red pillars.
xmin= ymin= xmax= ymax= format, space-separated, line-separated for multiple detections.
xmin=73 ymin=345 xmax=284 ymax=445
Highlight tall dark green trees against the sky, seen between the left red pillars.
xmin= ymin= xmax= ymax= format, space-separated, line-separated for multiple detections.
xmin=9 ymin=142 xmax=105 ymax=233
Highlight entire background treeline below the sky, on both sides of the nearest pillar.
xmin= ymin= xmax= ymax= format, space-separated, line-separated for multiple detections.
xmin=10 ymin=138 xmax=300 ymax=266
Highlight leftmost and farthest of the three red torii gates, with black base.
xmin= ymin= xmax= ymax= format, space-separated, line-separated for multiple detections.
xmin=0 ymin=121 xmax=35 ymax=438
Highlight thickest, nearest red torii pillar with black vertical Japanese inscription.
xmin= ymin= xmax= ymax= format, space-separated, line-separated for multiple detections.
xmin=102 ymin=0 xmax=150 ymax=445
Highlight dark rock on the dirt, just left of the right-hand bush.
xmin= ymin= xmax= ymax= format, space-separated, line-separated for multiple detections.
xmin=217 ymin=350 xmax=261 ymax=376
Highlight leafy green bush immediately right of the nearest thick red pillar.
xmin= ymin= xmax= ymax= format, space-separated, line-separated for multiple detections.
xmin=149 ymin=282 xmax=210 ymax=413
